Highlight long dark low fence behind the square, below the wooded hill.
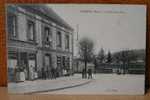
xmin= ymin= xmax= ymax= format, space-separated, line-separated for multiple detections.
xmin=95 ymin=63 xmax=145 ymax=74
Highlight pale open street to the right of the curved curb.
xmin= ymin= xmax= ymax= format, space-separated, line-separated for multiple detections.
xmin=41 ymin=74 xmax=145 ymax=95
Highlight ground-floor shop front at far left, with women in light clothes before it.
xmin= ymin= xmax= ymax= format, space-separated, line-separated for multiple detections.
xmin=8 ymin=50 xmax=37 ymax=81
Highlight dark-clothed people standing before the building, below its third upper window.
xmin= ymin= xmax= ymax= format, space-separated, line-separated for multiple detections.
xmin=42 ymin=67 xmax=57 ymax=79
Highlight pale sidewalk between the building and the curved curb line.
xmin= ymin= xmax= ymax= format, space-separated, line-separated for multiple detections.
xmin=8 ymin=74 xmax=91 ymax=94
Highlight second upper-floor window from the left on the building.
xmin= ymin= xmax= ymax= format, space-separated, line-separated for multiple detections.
xmin=27 ymin=21 xmax=35 ymax=41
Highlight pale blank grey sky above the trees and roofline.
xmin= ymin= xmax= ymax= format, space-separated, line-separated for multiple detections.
xmin=48 ymin=4 xmax=146 ymax=56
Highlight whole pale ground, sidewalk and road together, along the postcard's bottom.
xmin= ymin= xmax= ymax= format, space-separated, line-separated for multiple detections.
xmin=8 ymin=74 xmax=145 ymax=95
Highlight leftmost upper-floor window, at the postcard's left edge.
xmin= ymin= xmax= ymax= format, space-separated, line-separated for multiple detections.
xmin=7 ymin=14 xmax=17 ymax=38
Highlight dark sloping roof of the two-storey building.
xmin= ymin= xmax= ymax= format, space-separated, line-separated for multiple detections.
xmin=14 ymin=4 xmax=73 ymax=30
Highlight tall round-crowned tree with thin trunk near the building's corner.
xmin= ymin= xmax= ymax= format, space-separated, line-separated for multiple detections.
xmin=79 ymin=38 xmax=94 ymax=77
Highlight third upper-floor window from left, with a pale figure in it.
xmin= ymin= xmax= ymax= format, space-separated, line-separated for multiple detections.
xmin=44 ymin=27 xmax=52 ymax=46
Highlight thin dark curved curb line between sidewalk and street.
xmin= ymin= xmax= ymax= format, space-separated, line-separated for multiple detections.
xmin=23 ymin=80 xmax=92 ymax=94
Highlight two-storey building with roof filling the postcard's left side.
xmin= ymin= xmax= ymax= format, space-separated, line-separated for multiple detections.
xmin=7 ymin=5 xmax=73 ymax=80
